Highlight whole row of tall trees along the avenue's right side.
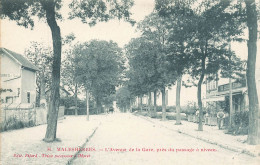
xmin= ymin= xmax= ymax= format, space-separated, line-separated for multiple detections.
xmin=123 ymin=0 xmax=259 ymax=144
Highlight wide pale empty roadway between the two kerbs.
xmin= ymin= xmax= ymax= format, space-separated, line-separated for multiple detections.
xmin=72 ymin=113 xmax=257 ymax=165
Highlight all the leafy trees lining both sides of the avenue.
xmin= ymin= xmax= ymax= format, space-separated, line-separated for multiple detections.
xmin=0 ymin=0 xmax=259 ymax=144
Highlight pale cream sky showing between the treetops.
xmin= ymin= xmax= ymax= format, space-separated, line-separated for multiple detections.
xmin=1 ymin=0 xmax=260 ymax=105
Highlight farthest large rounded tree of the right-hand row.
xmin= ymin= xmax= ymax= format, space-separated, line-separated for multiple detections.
xmin=125 ymin=38 xmax=154 ymax=113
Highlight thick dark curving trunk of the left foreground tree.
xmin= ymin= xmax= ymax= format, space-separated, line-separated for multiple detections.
xmin=40 ymin=1 xmax=61 ymax=142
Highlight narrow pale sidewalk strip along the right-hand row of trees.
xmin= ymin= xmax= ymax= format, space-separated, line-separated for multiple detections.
xmin=135 ymin=114 xmax=260 ymax=156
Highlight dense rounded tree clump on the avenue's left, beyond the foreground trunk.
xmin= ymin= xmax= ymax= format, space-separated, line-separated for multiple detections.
xmin=63 ymin=40 xmax=125 ymax=116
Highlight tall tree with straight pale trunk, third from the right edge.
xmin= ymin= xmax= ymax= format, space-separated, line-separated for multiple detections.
xmin=155 ymin=0 xmax=195 ymax=125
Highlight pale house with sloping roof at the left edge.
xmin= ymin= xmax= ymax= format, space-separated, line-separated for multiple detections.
xmin=0 ymin=48 xmax=38 ymax=106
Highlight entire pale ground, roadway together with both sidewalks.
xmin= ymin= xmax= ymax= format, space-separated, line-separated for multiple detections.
xmin=0 ymin=113 xmax=260 ymax=165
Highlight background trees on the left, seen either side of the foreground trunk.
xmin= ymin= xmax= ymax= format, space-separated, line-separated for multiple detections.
xmin=25 ymin=38 xmax=125 ymax=114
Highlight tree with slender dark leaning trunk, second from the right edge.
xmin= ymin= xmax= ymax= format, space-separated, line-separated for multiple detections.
xmin=187 ymin=0 xmax=242 ymax=131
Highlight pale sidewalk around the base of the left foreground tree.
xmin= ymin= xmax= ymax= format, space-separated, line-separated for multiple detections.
xmin=0 ymin=115 xmax=105 ymax=165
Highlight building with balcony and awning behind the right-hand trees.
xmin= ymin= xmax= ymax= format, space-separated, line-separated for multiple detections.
xmin=203 ymin=69 xmax=260 ymax=113
